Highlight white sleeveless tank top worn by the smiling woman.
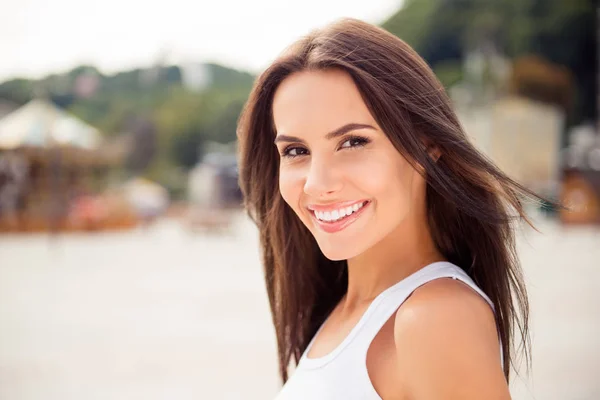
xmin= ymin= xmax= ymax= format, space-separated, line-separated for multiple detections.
xmin=275 ymin=262 xmax=502 ymax=400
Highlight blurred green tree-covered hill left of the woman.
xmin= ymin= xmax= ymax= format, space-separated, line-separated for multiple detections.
xmin=0 ymin=64 xmax=254 ymax=174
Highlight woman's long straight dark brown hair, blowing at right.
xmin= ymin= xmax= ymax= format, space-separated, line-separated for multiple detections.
xmin=238 ymin=19 xmax=537 ymax=382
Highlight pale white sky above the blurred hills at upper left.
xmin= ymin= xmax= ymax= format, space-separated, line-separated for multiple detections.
xmin=0 ymin=0 xmax=402 ymax=81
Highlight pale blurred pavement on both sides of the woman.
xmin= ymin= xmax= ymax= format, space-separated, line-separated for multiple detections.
xmin=0 ymin=216 xmax=600 ymax=400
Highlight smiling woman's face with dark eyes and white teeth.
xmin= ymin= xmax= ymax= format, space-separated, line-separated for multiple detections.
xmin=273 ymin=70 xmax=425 ymax=260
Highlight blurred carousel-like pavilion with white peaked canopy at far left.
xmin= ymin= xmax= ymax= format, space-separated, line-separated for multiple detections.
xmin=0 ymin=99 xmax=135 ymax=232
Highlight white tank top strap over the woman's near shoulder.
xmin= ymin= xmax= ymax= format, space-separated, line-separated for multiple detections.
xmin=355 ymin=261 xmax=494 ymax=356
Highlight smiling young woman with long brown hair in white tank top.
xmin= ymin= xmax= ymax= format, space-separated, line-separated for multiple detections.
xmin=238 ymin=20 xmax=535 ymax=400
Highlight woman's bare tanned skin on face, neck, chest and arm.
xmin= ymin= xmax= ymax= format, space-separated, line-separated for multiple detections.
xmin=273 ymin=70 xmax=510 ymax=400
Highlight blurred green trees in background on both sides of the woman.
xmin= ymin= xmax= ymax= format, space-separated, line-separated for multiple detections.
xmin=0 ymin=0 xmax=597 ymax=180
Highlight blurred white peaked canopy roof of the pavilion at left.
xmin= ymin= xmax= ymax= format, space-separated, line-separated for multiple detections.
xmin=0 ymin=99 xmax=101 ymax=150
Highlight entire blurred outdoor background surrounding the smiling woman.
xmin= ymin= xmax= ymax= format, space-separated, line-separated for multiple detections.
xmin=0 ymin=0 xmax=600 ymax=400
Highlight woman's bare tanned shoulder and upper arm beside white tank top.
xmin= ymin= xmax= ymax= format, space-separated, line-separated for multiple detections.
xmin=394 ymin=279 xmax=510 ymax=400
